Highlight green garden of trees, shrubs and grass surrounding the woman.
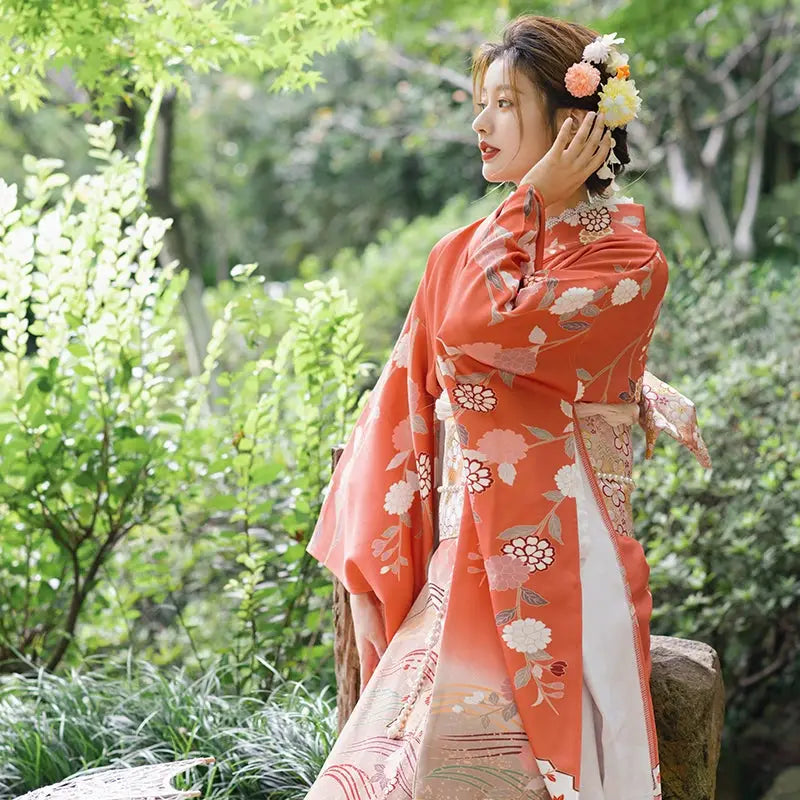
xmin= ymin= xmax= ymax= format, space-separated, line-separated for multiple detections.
xmin=0 ymin=0 xmax=800 ymax=800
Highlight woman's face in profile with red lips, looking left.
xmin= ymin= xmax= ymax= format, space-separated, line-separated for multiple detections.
xmin=472 ymin=58 xmax=569 ymax=184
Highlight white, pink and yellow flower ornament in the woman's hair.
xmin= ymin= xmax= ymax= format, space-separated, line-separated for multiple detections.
xmin=564 ymin=32 xmax=642 ymax=180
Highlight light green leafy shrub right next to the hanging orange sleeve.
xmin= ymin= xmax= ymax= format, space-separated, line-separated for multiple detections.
xmin=180 ymin=264 xmax=367 ymax=686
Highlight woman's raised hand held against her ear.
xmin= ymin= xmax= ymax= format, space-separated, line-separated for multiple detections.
xmin=520 ymin=111 xmax=613 ymax=206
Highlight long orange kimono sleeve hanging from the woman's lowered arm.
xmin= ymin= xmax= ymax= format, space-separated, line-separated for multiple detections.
xmin=306 ymin=268 xmax=435 ymax=642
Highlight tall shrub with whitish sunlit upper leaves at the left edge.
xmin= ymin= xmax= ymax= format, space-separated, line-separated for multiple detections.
xmin=0 ymin=123 xmax=190 ymax=667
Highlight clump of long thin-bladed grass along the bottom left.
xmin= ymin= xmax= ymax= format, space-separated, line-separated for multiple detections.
xmin=0 ymin=660 xmax=336 ymax=800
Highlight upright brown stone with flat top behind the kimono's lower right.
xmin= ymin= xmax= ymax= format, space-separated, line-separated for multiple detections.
xmin=650 ymin=636 xmax=725 ymax=800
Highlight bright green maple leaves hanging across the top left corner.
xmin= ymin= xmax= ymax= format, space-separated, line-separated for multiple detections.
xmin=0 ymin=0 xmax=369 ymax=113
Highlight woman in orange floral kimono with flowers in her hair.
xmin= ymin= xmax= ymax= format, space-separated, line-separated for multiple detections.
xmin=307 ymin=16 xmax=710 ymax=800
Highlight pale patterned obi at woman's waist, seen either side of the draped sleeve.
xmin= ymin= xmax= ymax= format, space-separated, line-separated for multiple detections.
xmin=436 ymin=392 xmax=639 ymax=541
